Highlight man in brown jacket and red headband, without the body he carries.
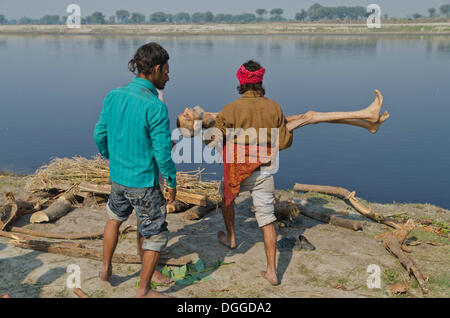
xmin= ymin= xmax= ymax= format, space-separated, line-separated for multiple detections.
xmin=215 ymin=61 xmax=293 ymax=285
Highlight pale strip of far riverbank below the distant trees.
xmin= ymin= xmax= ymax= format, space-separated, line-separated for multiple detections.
xmin=0 ymin=22 xmax=450 ymax=35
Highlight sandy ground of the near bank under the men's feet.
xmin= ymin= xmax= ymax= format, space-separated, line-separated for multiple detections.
xmin=0 ymin=176 xmax=450 ymax=298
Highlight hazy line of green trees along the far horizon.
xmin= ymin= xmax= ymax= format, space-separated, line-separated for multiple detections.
xmin=0 ymin=3 xmax=450 ymax=25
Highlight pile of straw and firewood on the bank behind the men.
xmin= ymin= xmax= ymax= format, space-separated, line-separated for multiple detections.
xmin=19 ymin=157 xmax=221 ymax=220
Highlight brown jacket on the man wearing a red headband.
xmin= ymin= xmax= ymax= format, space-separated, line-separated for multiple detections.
xmin=215 ymin=90 xmax=293 ymax=150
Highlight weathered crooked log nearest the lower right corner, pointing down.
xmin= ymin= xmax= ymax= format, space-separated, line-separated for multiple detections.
xmin=378 ymin=220 xmax=429 ymax=294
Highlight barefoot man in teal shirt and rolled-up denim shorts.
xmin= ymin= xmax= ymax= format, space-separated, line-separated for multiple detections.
xmin=94 ymin=43 xmax=176 ymax=297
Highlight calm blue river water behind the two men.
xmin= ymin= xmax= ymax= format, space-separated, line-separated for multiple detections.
xmin=0 ymin=36 xmax=450 ymax=208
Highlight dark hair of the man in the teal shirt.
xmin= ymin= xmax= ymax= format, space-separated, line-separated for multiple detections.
xmin=128 ymin=42 xmax=169 ymax=76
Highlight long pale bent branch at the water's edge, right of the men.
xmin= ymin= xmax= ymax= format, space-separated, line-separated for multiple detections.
xmin=294 ymin=183 xmax=400 ymax=229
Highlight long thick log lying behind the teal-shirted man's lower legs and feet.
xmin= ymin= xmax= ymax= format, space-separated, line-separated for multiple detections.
xmin=9 ymin=239 xmax=192 ymax=266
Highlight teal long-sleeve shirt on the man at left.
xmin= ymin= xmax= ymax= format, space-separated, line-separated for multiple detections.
xmin=94 ymin=77 xmax=176 ymax=188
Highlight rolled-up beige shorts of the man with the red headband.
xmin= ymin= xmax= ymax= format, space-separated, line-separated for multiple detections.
xmin=220 ymin=171 xmax=277 ymax=227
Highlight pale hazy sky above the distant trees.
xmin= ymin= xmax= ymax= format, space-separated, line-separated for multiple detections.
xmin=0 ymin=0 xmax=450 ymax=19
